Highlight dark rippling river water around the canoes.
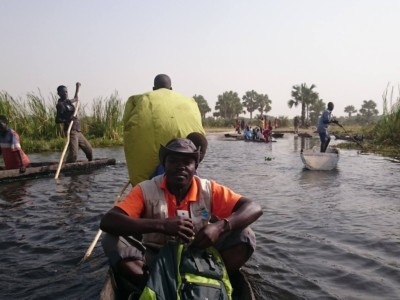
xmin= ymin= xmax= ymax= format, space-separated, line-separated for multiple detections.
xmin=0 ymin=134 xmax=400 ymax=299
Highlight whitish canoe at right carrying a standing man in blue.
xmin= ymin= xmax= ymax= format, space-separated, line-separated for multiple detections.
xmin=300 ymin=147 xmax=339 ymax=171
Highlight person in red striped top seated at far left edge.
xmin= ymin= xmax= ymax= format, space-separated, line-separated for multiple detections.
xmin=0 ymin=115 xmax=30 ymax=173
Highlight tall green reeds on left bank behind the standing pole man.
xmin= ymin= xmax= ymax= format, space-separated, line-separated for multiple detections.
xmin=0 ymin=90 xmax=123 ymax=152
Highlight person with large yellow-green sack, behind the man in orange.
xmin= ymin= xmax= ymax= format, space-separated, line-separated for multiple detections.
xmin=123 ymin=74 xmax=205 ymax=185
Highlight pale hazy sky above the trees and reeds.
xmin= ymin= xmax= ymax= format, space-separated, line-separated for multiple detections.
xmin=0 ymin=0 xmax=400 ymax=117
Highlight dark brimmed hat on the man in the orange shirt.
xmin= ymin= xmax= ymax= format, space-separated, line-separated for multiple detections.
xmin=159 ymin=138 xmax=200 ymax=167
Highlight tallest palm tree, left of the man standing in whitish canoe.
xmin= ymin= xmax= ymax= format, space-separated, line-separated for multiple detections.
xmin=288 ymin=83 xmax=319 ymax=127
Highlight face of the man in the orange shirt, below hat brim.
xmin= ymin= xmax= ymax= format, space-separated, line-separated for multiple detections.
xmin=165 ymin=154 xmax=196 ymax=187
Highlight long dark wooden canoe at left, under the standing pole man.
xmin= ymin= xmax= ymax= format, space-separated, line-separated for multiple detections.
xmin=0 ymin=158 xmax=115 ymax=183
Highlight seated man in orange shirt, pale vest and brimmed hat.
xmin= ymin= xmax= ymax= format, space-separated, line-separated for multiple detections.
xmin=100 ymin=138 xmax=262 ymax=292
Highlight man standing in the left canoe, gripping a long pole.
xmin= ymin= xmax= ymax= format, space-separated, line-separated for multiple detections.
xmin=56 ymin=82 xmax=93 ymax=163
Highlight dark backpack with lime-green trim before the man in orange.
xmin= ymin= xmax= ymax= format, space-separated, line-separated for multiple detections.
xmin=139 ymin=241 xmax=232 ymax=300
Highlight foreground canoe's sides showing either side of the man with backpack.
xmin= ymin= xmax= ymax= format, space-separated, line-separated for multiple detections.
xmin=100 ymin=269 xmax=256 ymax=300
